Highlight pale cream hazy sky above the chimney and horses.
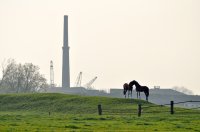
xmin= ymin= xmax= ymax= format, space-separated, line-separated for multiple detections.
xmin=0 ymin=0 xmax=200 ymax=94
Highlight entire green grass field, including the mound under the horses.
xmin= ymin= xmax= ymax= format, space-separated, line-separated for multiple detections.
xmin=0 ymin=93 xmax=200 ymax=132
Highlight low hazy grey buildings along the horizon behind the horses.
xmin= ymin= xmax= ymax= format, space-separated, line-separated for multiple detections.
xmin=47 ymin=87 xmax=200 ymax=107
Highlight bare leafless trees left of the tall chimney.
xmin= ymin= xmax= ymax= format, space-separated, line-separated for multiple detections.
xmin=0 ymin=59 xmax=49 ymax=93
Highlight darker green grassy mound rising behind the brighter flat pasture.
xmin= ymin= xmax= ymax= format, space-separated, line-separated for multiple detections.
xmin=0 ymin=93 xmax=149 ymax=114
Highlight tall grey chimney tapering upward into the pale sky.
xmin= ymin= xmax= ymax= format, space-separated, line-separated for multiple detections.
xmin=62 ymin=15 xmax=70 ymax=88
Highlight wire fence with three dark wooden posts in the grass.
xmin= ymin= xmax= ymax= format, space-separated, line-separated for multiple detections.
xmin=98 ymin=100 xmax=200 ymax=116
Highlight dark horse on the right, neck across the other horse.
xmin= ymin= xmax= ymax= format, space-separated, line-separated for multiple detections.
xmin=129 ymin=80 xmax=149 ymax=101
